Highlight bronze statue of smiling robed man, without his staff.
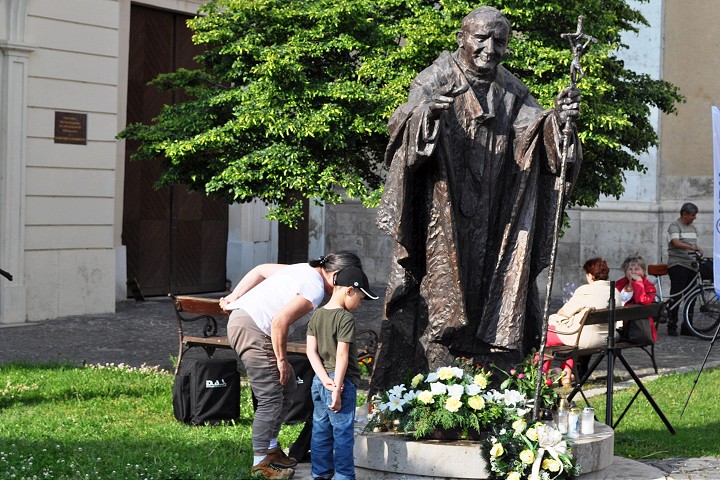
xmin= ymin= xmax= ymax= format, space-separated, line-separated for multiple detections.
xmin=373 ymin=7 xmax=580 ymax=388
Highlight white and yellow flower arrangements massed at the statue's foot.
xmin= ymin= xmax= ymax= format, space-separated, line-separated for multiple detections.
xmin=366 ymin=355 xmax=579 ymax=480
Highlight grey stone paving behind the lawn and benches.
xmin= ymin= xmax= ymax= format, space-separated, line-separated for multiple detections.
xmin=0 ymin=289 xmax=720 ymax=480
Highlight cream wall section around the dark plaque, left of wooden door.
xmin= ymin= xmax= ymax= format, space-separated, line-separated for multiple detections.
xmin=20 ymin=0 xmax=119 ymax=321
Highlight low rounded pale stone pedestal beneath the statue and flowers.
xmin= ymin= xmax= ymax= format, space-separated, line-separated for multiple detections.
xmin=355 ymin=422 xmax=615 ymax=480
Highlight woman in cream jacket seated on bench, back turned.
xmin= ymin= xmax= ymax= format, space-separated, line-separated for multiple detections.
xmin=545 ymin=258 xmax=620 ymax=386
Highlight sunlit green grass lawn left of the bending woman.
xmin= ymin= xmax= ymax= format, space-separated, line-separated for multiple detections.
xmin=0 ymin=365 xmax=302 ymax=480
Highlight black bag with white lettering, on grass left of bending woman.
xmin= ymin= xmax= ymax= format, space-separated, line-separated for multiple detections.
xmin=173 ymin=358 xmax=240 ymax=425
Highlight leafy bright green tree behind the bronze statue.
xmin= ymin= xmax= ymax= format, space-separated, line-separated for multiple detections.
xmin=120 ymin=0 xmax=682 ymax=224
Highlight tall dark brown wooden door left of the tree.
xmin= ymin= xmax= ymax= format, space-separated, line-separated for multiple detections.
xmin=122 ymin=5 xmax=228 ymax=296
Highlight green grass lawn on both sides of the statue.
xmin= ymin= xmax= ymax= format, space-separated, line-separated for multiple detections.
xmin=0 ymin=364 xmax=720 ymax=480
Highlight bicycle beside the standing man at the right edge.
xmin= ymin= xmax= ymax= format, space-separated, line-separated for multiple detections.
xmin=647 ymin=254 xmax=720 ymax=340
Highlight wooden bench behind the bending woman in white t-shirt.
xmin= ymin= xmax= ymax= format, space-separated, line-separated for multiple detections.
xmin=168 ymin=294 xmax=378 ymax=375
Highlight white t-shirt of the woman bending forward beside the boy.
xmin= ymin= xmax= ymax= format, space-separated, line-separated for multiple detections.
xmin=226 ymin=263 xmax=325 ymax=336
